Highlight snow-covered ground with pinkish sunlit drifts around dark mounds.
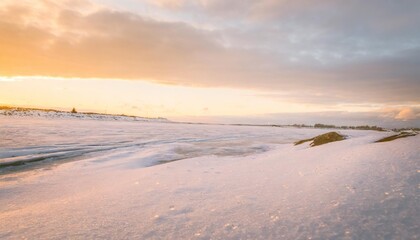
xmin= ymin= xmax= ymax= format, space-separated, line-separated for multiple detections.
xmin=0 ymin=116 xmax=420 ymax=239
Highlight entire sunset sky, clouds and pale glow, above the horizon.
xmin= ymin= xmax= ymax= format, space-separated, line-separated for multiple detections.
xmin=0 ymin=0 xmax=420 ymax=127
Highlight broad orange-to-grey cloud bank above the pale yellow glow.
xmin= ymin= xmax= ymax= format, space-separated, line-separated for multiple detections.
xmin=0 ymin=0 xmax=420 ymax=104
